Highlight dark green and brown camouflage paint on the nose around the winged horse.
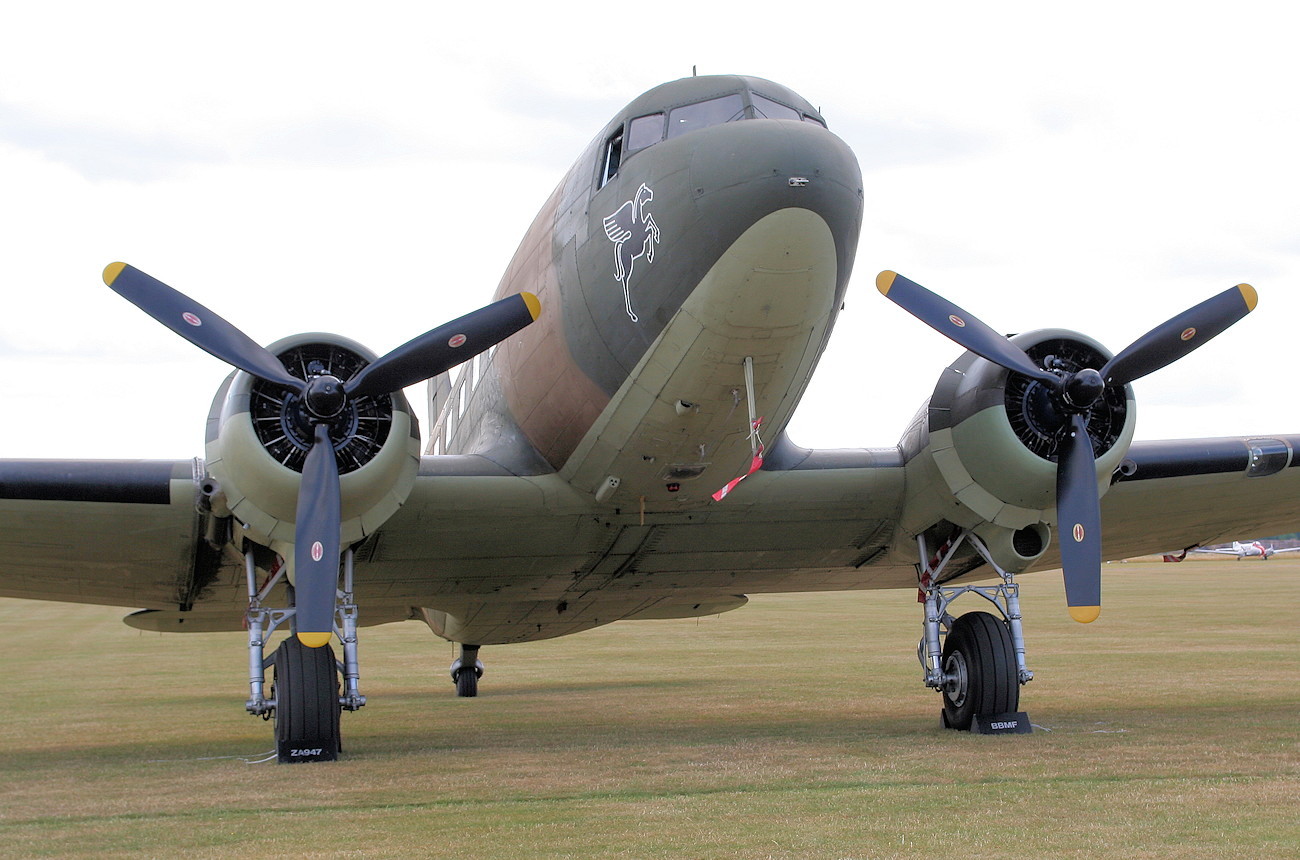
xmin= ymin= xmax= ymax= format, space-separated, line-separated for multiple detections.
xmin=494 ymin=77 xmax=862 ymax=469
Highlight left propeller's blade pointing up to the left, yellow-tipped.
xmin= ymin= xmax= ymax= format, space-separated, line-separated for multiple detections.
xmin=104 ymin=262 xmax=303 ymax=391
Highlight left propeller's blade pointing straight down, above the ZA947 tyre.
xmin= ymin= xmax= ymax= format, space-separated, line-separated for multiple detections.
xmin=294 ymin=424 xmax=342 ymax=648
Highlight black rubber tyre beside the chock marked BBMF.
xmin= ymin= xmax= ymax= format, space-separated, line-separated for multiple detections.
xmin=943 ymin=612 xmax=1021 ymax=731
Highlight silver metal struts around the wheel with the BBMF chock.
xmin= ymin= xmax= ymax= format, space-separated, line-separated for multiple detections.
xmin=917 ymin=529 xmax=1034 ymax=690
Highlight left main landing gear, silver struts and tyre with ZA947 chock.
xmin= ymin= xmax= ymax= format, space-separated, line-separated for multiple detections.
xmin=244 ymin=550 xmax=365 ymax=763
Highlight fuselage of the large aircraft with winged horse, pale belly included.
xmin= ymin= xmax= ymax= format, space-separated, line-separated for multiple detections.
xmin=433 ymin=77 xmax=862 ymax=505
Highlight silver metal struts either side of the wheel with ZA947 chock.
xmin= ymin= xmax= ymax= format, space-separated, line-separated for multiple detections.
xmin=244 ymin=548 xmax=365 ymax=720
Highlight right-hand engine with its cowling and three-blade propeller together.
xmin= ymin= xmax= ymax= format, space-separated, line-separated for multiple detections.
xmin=876 ymin=270 xmax=1258 ymax=615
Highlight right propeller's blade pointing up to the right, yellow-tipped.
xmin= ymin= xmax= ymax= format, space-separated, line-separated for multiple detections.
xmin=1101 ymin=283 xmax=1260 ymax=386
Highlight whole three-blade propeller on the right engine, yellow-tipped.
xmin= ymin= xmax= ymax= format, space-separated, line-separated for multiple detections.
xmin=876 ymin=272 xmax=1258 ymax=624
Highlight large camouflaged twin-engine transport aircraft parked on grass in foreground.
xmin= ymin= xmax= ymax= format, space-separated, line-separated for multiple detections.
xmin=0 ymin=77 xmax=1300 ymax=761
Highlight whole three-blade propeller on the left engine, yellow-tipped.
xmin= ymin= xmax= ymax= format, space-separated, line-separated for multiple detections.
xmin=104 ymin=262 xmax=541 ymax=648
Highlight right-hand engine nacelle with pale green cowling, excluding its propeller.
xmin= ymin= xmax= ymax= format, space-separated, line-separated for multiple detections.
xmin=904 ymin=329 xmax=1136 ymax=570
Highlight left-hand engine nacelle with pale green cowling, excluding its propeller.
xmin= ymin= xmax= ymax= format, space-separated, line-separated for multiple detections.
xmin=207 ymin=334 xmax=420 ymax=552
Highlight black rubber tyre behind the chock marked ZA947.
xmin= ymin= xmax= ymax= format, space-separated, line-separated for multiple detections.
xmin=273 ymin=637 xmax=342 ymax=764
